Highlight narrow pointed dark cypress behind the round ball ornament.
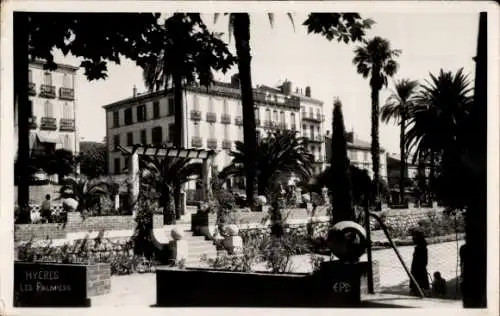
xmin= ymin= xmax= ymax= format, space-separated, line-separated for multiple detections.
xmin=329 ymin=99 xmax=354 ymax=224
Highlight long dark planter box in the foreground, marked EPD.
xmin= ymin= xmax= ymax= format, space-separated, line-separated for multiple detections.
xmin=156 ymin=267 xmax=372 ymax=307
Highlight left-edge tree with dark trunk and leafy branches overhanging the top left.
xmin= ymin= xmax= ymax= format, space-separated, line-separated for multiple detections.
xmin=14 ymin=12 xmax=166 ymax=215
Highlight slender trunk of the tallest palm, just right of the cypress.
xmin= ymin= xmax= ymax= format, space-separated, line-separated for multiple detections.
xmin=371 ymin=84 xmax=381 ymax=211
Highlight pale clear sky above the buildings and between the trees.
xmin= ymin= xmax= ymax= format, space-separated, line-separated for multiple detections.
xmin=52 ymin=12 xmax=478 ymax=153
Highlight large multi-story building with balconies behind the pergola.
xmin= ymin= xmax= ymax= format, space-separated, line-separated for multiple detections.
xmin=103 ymin=75 xmax=324 ymax=180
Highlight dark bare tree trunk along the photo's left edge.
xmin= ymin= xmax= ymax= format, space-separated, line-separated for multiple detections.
xmin=14 ymin=12 xmax=32 ymax=222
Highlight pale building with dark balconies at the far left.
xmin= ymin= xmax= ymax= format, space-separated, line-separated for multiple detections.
xmin=14 ymin=61 xmax=80 ymax=160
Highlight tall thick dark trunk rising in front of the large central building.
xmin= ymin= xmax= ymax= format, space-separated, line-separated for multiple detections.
xmin=233 ymin=13 xmax=257 ymax=206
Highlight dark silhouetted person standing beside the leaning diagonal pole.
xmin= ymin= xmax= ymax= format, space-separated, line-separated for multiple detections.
xmin=410 ymin=230 xmax=430 ymax=295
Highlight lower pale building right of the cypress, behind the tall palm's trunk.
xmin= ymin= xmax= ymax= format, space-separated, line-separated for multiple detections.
xmin=325 ymin=132 xmax=387 ymax=181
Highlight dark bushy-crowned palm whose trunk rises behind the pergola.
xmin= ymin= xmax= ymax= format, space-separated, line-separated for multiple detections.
xmin=143 ymin=13 xmax=235 ymax=219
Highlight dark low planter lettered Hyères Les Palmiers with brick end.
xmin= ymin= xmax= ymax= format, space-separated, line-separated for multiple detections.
xmin=14 ymin=262 xmax=111 ymax=307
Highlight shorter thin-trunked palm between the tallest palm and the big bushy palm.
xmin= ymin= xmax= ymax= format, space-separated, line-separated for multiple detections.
xmin=381 ymin=79 xmax=418 ymax=203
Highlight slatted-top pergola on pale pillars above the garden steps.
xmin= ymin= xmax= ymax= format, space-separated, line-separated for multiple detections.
xmin=116 ymin=145 xmax=216 ymax=210
